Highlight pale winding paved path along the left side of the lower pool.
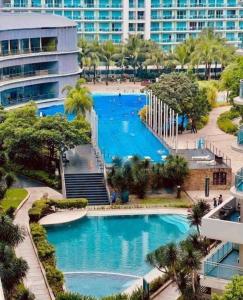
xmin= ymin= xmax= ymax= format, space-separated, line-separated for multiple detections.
xmin=14 ymin=187 xmax=62 ymax=300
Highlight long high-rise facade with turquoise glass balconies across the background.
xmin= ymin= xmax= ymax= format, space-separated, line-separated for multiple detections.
xmin=1 ymin=0 xmax=243 ymax=51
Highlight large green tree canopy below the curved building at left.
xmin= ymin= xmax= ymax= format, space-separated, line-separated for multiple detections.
xmin=0 ymin=103 xmax=90 ymax=167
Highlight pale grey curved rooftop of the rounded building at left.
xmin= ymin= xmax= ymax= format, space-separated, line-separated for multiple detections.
xmin=0 ymin=13 xmax=76 ymax=31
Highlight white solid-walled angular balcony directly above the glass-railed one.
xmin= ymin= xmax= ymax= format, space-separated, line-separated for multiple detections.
xmin=201 ymin=197 xmax=243 ymax=244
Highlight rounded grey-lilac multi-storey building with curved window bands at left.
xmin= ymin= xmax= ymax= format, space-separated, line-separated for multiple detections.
xmin=0 ymin=13 xmax=80 ymax=107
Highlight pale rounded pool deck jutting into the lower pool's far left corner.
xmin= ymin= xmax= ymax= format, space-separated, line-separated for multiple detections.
xmin=39 ymin=209 xmax=87 ymax=226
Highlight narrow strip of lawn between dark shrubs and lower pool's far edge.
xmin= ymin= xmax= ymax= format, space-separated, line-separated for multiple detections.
xmin=131 ymin=193 xmax=192 ymax=208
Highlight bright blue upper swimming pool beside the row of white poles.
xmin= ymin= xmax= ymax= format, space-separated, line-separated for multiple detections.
xmin=40 ymin=94 xmax=169 ymax=163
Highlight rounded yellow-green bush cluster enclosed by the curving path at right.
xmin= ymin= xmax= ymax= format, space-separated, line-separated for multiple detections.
xmin=217 ymin=108 xmax=240 ymax=134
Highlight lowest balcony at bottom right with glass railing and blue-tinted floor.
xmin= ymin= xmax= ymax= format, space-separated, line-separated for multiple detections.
xmin=202 ymin=242 xmax=243 ymax=289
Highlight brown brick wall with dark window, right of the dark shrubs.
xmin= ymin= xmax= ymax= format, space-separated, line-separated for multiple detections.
xmin=184 ymin=168 xmax=232 ymax=191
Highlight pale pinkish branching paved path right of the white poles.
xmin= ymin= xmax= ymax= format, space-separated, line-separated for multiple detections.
xmin=178 ymin=106 xmax=243 ymax=173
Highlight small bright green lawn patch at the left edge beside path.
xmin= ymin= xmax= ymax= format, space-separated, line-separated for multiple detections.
xmin=0 ymin=188 xmax=28 ymax=210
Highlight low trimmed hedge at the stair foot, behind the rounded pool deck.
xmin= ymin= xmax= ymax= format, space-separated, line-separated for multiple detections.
xmin=29 ymin=199 xmax=88 ymax=222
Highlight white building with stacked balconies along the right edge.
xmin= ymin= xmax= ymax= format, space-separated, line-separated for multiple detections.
xmin=201 ymin=81 xmax=243 ymax=293
